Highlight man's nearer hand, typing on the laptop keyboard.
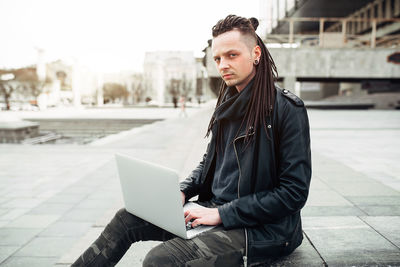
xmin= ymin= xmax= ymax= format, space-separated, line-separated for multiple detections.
xmin=185 ymin=207 xmax=222 ymax=227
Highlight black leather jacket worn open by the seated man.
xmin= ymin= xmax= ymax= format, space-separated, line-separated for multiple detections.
xmin=180 ymin=86 xmax=311 ymax=266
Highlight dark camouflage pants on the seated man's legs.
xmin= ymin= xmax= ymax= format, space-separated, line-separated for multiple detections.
xmin=72 ymin=203 xmax=245 ymax=267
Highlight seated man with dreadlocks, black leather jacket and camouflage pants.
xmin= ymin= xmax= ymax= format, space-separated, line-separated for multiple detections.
xmin=74 ymin=15 xmax=311 ymax=266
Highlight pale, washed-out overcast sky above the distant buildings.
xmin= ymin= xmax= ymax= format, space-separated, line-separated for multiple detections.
xmin=0 ymin=0 xmax=260 ymax=72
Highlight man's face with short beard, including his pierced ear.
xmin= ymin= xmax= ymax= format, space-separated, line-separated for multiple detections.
xmin=212 ymin=30 xmax=261 ymax=92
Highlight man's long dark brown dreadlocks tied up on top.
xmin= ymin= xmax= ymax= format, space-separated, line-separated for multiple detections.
xmin=206 ymin=15 xmax=278 ymax=150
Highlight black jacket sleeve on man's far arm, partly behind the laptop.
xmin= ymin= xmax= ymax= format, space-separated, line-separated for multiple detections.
xmin=179 ymin=143 xmax=210 ymax=201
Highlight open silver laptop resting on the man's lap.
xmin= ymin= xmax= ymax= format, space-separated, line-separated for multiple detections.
xmin=115 ymin=154 xmax=215 ymax=239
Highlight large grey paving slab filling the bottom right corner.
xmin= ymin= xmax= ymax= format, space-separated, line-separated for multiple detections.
xmin=303 ymin=216 xmax=400 ymax=266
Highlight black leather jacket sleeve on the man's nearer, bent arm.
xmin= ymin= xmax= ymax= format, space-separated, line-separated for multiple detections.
xmin=218 ymin=103 xmax=311 ymax=229
